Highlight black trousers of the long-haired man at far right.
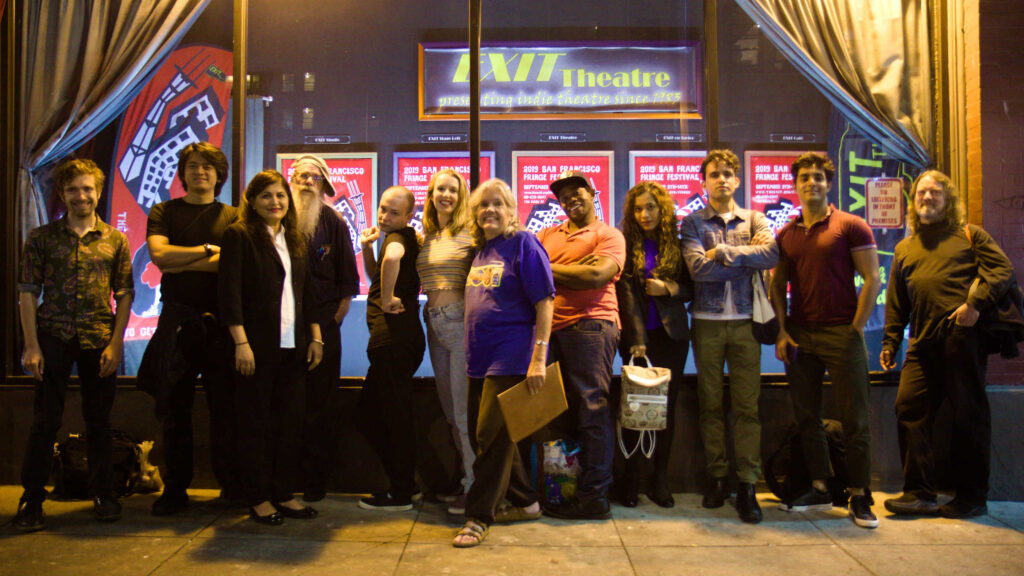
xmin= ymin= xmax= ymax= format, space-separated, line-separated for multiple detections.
xmin=896 ymin=326 xmax=992 ymax=502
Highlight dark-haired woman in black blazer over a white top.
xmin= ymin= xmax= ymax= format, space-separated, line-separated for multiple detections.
xmin=218 ymin=170 xmax=324 ymax=526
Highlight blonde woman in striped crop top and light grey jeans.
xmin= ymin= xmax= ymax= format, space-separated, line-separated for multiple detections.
xmin=416 ymin=169 xmax=475 ymax=515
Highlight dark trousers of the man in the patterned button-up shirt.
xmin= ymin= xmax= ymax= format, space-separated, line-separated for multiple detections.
xmin=22 ymin=333 xmax=117 ymax=502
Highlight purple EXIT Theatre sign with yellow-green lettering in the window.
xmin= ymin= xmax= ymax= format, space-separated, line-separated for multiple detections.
xmin=419 ymin=42 xmax=702 ymax=120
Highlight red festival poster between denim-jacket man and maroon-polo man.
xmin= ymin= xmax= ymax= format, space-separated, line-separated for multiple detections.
xmin=740 ymin=151 xmax=803 ymax=233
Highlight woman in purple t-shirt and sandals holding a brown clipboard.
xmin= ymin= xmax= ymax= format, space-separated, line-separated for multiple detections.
xmin=453 ymin=178 xmax=555 ymax=548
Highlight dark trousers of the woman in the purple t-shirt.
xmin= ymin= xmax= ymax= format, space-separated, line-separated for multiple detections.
xmin=466 ymin=375 xmax=537 ymax=524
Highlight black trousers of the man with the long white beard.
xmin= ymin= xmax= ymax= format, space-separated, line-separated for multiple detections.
xmin=299 ymin=321 xmax=341 ymax=492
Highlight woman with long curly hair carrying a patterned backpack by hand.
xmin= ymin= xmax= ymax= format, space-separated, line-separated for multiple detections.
xmin=615 ymin=181 xmax=693 ymax=507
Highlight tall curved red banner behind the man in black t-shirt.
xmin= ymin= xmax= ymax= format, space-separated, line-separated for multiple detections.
xmin=110 ymin=46 xmax=231 ymax=341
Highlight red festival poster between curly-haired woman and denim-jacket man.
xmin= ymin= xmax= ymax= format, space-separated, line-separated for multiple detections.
xmin=630 ymin=152 xmax=708 ymax=221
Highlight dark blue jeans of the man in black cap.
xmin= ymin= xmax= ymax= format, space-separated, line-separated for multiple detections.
xmin=548 ymin=319 xmax=618 ymax=500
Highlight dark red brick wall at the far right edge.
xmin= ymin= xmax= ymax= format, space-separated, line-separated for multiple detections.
xmin=968 ymin=0 xmax=1024 ymax=384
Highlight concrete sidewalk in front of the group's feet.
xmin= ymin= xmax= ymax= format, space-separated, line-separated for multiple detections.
xmin=0 ymin=486 xmax=1024 ymax=576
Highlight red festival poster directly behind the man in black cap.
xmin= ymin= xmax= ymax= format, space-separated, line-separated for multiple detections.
xmin=512 ymin=152 xmax=615 ymax=234
